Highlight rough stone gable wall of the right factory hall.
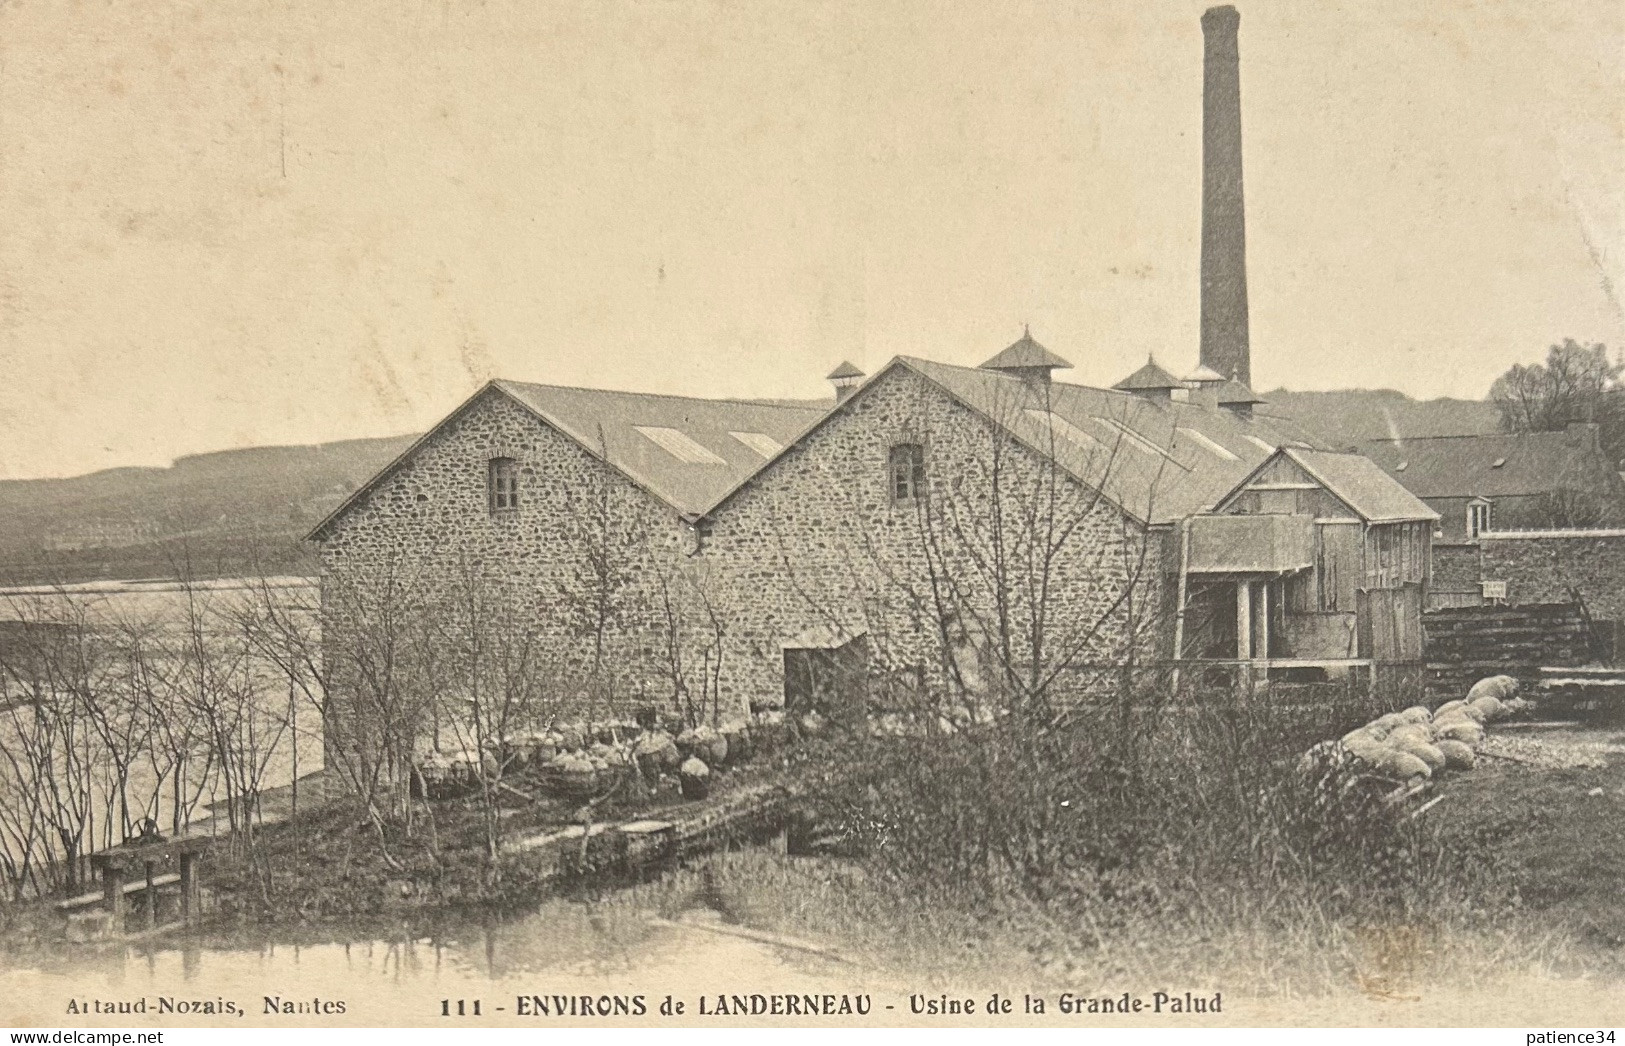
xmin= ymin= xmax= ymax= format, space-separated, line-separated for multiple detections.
xmin=704 ymin=369 xmax=1165 ymax=708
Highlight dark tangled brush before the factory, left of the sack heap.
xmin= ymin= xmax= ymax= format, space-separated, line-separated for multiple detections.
xmin=786 ymin=665 xmax=1488 ymax=913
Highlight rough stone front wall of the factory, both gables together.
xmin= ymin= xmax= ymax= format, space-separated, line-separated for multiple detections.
xmin=322 ymin=369 xmax=1167 ymax=740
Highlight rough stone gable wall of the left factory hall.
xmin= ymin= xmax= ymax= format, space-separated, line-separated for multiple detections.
xmin=320 ymin=390 xmax=700 ymax=734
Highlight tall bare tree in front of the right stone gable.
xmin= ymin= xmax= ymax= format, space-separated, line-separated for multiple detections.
xmin=767 ymin=385 xmax=1183 ymax=897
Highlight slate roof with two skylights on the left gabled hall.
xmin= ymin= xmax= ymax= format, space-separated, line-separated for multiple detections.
xmin=307 ymin=380 xmax=829 ymax=539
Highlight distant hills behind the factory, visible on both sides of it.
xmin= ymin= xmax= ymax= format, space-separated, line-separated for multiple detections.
xmin=0 ymin=390 xmax=1498 ymax=585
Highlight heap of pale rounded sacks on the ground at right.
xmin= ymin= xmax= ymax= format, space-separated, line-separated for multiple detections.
xmin=1337 ymin=676 xmax=1528 ymax=781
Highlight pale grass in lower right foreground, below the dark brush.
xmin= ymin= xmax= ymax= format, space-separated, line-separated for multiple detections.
xmin=575 ymin=733 xmax=1625 ymax=1001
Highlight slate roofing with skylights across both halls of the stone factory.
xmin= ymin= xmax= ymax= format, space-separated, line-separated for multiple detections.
xmin=309 ymin=350 xmax=1433 ymax=539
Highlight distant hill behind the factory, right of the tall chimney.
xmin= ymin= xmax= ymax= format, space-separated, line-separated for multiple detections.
xmin=1261 ymin=388 xmax=1502 ymax=448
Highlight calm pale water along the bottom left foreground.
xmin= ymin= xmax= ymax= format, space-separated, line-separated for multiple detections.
xmin=0 ymin=883 xmax=873 ymax=1027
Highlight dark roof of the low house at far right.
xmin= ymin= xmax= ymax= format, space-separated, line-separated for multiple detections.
xmin=1363 ymin=432 xmax=1617 ymax=497
